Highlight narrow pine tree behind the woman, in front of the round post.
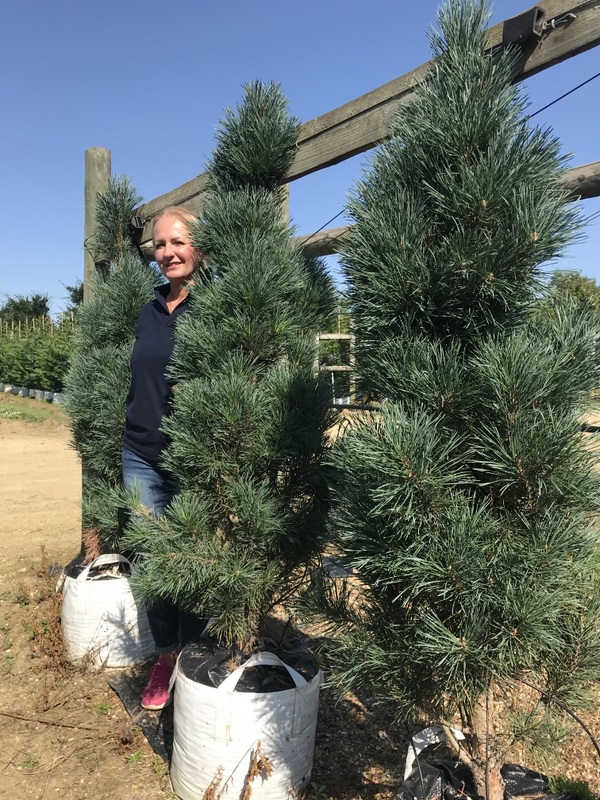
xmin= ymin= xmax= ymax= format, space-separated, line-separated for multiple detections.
xmin=65 ymin=177 xmax=161 ymax=557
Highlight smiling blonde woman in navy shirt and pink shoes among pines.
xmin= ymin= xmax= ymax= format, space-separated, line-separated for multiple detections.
xmin=123 ymin=206 xmax=203 ymax=710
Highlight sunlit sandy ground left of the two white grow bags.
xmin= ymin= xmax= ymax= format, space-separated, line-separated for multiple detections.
xmin=0 ymin=418 xmax=170 ymax=800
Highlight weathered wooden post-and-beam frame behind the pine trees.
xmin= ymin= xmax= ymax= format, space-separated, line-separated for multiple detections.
xmin=84 ymin=0 xmax=600 ymax=299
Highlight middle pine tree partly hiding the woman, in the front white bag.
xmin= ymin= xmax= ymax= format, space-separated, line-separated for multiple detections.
xmin=127 ymin=83 xmax=335 ymax=647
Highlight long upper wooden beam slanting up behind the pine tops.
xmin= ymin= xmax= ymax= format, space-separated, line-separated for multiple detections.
xmin=134 ymin=0 xmax=600 ymax=243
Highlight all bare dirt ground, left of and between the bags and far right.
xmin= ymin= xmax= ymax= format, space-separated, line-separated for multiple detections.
xmin=0 ymin=396 xmax=600 ymax=800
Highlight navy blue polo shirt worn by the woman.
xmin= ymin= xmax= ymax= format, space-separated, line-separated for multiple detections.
xmin=123 ymin=284 xmax=189 ymax=463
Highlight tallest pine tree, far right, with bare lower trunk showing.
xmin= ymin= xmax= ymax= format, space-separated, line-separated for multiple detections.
xmin=302 ymin=0 xmax=600 ymax=797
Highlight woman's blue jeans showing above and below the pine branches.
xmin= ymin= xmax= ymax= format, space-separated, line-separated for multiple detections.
xmin=122 ymin=448 xmax=179 ymax=653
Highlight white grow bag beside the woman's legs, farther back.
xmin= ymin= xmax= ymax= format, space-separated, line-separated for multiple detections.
xmin=57 ymin=553 xmax=154 ymax=667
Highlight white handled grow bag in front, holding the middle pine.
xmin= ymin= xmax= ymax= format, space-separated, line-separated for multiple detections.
xmin=171 ymin=652 xmax=323 ymax=800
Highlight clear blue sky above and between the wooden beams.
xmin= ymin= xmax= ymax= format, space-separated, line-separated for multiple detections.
xmin=0 ymin=0 xmax=600 ymax=313
